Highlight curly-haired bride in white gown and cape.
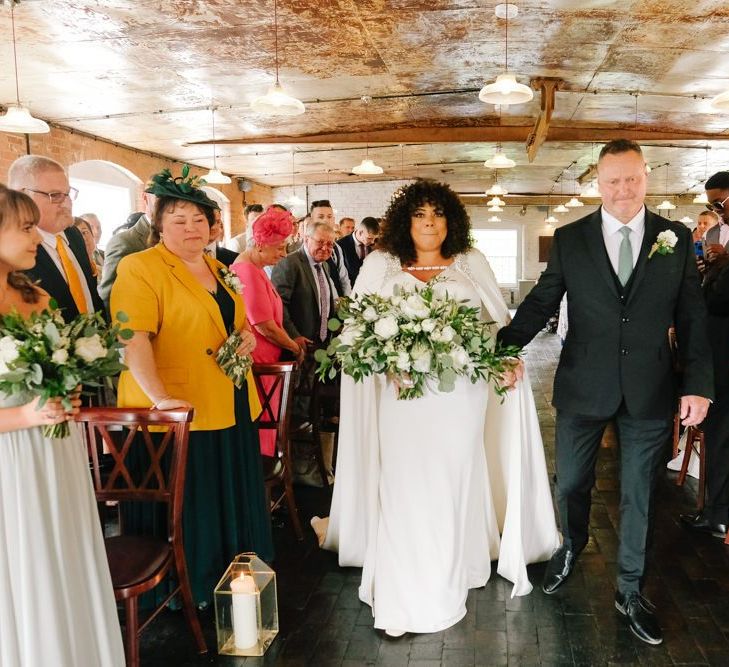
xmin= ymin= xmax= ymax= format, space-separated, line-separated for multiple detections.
xmin=312 ymin=180 xmax=560 ymax=636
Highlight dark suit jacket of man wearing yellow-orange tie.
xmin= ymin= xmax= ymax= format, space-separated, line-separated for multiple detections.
xmin=26 ymin=227 xmax=105 ymax=321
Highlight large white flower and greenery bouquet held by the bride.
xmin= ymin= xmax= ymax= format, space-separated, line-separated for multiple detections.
xmin=315 ymin=280 xmax=518 ymax=399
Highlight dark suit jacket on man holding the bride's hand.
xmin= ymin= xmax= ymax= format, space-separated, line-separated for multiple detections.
xmin=498 ymin=209 xmax=714 ymax=419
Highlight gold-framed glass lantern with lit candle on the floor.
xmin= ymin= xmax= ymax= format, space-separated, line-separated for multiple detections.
xmin=214 ymin=553 xmax=278 ymax=655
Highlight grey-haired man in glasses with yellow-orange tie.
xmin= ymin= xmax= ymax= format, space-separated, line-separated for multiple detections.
xmin=8 ymin=155 xmax=104 ymax=320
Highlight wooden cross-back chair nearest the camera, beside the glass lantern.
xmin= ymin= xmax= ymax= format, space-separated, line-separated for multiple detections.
xmin=77 ymin=408 xmax=207 ymax=667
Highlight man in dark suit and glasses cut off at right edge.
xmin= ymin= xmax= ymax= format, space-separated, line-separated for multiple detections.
xmin=681 ymin=171 xmax=729 ymax=539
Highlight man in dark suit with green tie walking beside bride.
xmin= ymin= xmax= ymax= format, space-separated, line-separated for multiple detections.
xmin=499 ymin=139 xmax=713 ymax=644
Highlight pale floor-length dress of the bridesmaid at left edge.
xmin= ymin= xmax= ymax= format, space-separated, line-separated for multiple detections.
xmin=0 ymin=394 xmax=124 ymax=667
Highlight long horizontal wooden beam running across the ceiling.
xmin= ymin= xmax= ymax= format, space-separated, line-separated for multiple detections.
xmin=195 ymin=125 xmax=729 ymax=146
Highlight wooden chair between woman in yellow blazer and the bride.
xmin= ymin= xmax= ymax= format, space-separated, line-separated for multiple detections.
xmin=253 ymin=361 xmax=304 ymax=540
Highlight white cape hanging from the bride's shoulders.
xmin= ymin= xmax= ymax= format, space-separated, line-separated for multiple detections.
xmin=322 ymin=250 xmax=560 ymax=602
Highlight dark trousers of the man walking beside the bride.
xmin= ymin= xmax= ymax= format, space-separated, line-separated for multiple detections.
xmin=556 ymin=406 xmax=671 ymax=593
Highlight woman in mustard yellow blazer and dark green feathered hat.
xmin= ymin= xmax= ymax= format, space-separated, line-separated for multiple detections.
xmin=111 ymin=170 xmax=273 ymax=605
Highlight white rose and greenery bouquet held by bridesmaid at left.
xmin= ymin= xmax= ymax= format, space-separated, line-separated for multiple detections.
xmin=0 ymin=308 xmax=134 ymax=438
